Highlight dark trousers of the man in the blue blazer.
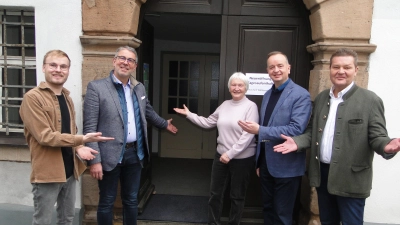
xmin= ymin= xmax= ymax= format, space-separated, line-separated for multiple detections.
xmin=259 ymin=157 xmax=301 ymax=225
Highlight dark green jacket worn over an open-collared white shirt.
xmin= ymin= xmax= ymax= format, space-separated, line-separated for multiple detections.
xmin=293 ymin=85 xmax=395 ymax=198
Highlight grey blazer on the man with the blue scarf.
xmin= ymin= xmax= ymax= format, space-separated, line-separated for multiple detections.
xmin=83 ymin=71 xmax=168 ymax=171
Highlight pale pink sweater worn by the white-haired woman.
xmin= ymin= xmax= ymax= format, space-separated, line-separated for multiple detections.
xmin=186 ymin=96 xmax=258 ymax=159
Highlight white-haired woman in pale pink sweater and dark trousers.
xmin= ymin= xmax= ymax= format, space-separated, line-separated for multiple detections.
xmin=174 ymin=72 xmax=258 ymax=224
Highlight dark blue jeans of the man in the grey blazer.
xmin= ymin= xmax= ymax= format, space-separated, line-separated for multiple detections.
xmin=97 ymin=147 xmax=142 ymax=225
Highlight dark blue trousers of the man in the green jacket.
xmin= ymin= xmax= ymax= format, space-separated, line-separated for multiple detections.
xmin=317 ymin=163 xmax=365 ymax=225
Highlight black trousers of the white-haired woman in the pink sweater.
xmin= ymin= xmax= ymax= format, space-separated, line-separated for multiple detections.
xmin=208 ymin=153 xmax=254 ymax=225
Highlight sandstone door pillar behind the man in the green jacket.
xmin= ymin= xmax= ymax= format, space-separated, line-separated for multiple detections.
xmin=301 ymin=0 xmax=376 ymax=225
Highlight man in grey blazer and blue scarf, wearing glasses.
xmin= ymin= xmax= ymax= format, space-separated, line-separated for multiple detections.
xmin=83 ymin=46 xmax=178 ymax=225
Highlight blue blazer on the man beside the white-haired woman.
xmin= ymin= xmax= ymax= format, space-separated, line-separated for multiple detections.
xmin=256 ymin=80 xmax=311 ymax=178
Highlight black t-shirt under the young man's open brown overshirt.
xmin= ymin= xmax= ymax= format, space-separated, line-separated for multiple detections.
xmin=57 ymin=95 xmax=74 ymax=179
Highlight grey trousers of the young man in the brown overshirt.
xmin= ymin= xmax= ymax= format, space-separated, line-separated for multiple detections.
xmin=32 ymin=176 xmax=76 ymax=225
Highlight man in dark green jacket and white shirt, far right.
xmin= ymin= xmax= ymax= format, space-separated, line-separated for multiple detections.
xmin=274 ymin=49 xmax=400 ymax=225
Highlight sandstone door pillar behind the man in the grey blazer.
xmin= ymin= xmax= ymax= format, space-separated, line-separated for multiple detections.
xmin=80 ymin=0 xmax=147 ymax=225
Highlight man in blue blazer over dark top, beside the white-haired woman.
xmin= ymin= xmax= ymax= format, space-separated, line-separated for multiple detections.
xmin=239 ymin=51 xmax=311 ymax=225
